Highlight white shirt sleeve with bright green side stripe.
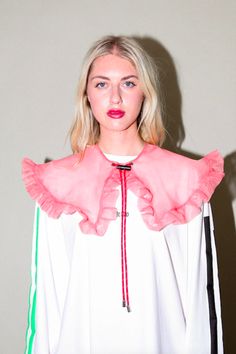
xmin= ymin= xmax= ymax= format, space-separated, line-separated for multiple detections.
xmin=25 ymin=205 xmax=69 ymax=354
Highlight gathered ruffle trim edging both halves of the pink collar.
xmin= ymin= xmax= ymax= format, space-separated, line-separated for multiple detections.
xmin=22 ymin=151 xmax=224 ymax=236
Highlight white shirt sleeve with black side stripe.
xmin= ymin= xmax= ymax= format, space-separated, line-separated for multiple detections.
xmin=186 ymin=203 xmax=223 ymax=354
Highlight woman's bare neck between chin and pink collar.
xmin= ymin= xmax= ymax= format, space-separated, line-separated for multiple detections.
xmin=98 ymin=131 xmax=144 ymax=156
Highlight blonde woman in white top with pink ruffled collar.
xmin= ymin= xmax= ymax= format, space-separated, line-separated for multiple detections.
xmin=23 ymin=36 xmax=223 ymax=354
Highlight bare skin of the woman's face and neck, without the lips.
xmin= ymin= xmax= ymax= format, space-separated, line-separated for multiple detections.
xmin=87 ymin=54 xmax=144 ymax=155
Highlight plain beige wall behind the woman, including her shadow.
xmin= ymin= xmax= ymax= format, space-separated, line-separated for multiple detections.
xmin=0 ymin=0 xmax=236 ymax=354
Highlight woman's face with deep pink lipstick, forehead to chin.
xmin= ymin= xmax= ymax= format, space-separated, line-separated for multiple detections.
xmin=87 ymin=54 xmax=144 ymax=134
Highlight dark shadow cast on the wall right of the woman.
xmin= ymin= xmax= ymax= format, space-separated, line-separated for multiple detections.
xmin=134 ymin=37 xmax=236 ymax=354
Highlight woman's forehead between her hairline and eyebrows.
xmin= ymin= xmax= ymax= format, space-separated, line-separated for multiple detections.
xmin=89 ymin=54 xmax=137 ymax=76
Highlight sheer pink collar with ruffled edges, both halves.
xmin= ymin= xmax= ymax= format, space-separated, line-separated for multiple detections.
xmin=23 ymin=144 xmax=224 ymax=235
